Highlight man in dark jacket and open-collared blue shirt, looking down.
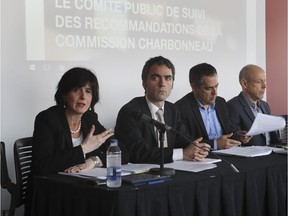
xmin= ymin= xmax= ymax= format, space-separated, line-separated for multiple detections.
xmin=176 ymin=63 xmax=241 ymax=149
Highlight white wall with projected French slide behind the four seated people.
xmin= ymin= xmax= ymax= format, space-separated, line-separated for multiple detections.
xmin=0 ymin=0 xmax=265 ymax=213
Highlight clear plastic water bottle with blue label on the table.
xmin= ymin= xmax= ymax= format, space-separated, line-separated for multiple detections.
xmin=106 ymin=139 xmax=122 ymax=188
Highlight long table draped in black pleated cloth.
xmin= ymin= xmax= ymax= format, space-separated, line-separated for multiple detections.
xmin=32 ymin=153 xmax=287 ymax=216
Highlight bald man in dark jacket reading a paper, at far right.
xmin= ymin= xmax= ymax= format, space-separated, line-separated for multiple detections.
xmin=228 ymin=65 xmax=281 ymax=145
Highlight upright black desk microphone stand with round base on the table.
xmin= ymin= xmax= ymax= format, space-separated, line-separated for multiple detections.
xmin=149 ymin=126 xmax=175 ymax=176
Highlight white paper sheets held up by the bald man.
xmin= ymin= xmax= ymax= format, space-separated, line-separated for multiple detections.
xmin=245 ymin=113 xmax=286 ymax=136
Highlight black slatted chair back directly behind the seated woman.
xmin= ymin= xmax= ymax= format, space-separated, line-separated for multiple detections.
xmin=14 ymin=137 xmax=33 ymax=207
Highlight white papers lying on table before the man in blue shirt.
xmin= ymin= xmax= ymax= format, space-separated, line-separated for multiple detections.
xmin=213 ymin=146 xmax=272 ymax=157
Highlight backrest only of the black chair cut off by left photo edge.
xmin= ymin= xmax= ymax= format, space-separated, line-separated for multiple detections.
xmin=1 ymin=141 xmax=12 ymax=192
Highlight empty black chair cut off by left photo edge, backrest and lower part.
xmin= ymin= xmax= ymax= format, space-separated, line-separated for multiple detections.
xmin=1 ymin=141 xmax=18 ymax=216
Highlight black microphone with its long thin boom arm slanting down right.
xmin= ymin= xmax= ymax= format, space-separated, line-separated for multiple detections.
xmin=132 ymin=111 xmax=239 ymax=172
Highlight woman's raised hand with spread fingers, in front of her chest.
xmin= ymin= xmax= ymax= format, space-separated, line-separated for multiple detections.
xmin=81 ymin=125 xmax=114 ymax=154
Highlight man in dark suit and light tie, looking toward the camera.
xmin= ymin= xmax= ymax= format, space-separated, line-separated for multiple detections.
xmin=115 ymin=56 xmax=209 ymax=163
